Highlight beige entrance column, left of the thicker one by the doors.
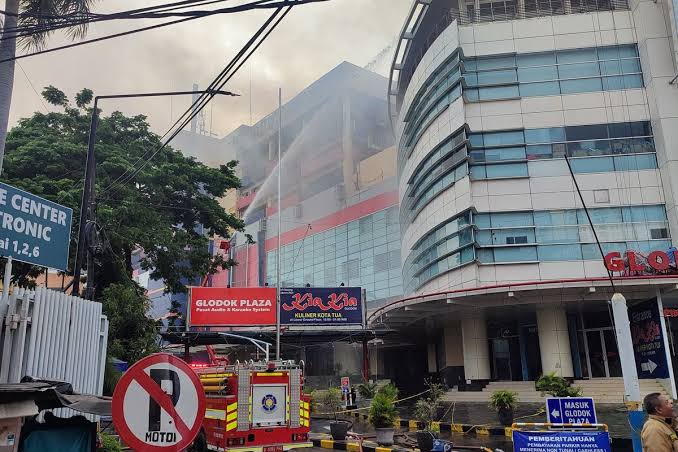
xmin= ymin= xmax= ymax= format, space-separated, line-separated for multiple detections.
xmin=461 ymin=315 xmax=491 ymax=380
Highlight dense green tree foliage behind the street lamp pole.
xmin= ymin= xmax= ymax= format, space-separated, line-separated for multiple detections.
xmin=3 ymin=87 xmax=243 ymax=297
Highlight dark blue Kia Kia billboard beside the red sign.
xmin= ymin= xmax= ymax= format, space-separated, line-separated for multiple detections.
xmin=280 ymin=287 xmax=365 ymax=327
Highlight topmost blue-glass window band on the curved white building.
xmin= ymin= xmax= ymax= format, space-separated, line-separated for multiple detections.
xmin=399 ymin=44 xmax=643 ymax=162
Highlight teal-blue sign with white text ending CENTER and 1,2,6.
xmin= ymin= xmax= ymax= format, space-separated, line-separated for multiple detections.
xmin=0 ymin=182 xmax=73 ymax=270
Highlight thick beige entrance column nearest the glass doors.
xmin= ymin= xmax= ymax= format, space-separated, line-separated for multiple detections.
xmin=537 ymin=305 xmax=574 ymax=377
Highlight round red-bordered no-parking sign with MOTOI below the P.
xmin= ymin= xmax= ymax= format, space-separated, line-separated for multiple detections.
xmin=113 ymin=353 xmax=205 ymax=452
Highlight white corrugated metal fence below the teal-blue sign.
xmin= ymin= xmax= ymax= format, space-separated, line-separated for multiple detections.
xmin=0 ymin=288 xmax=108 ymax=395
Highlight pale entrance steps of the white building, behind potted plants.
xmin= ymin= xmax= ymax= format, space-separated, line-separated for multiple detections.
xmin=443 ymin=378 xmax=668 ymax=404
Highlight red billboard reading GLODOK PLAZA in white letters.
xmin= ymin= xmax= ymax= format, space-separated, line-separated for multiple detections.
xmin=189 ymin=287 xmax=276 ymax=326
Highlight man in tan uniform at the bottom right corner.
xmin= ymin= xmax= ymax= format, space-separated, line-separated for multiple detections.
xmin=640 ymin=392 xmax=678 ymax=452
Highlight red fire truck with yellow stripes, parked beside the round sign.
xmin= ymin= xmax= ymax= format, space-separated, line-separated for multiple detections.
xmin=193 ymin=361 xmax=312 ymax=452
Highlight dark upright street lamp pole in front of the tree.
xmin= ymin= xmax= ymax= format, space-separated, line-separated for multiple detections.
xmin=71 ymin=96 xmax=99 ymax=296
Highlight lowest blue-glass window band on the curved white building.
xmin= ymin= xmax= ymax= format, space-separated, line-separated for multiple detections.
xmin=403 ymin=205 xmax=671 ymax=293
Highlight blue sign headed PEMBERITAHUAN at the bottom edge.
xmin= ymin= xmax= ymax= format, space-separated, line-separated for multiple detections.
xmin=513 ymin=430 xmax=612 ymax=452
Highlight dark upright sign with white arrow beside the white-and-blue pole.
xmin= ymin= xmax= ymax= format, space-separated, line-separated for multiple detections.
xmin=629 ymin=298 xmax=669 ymax=379
